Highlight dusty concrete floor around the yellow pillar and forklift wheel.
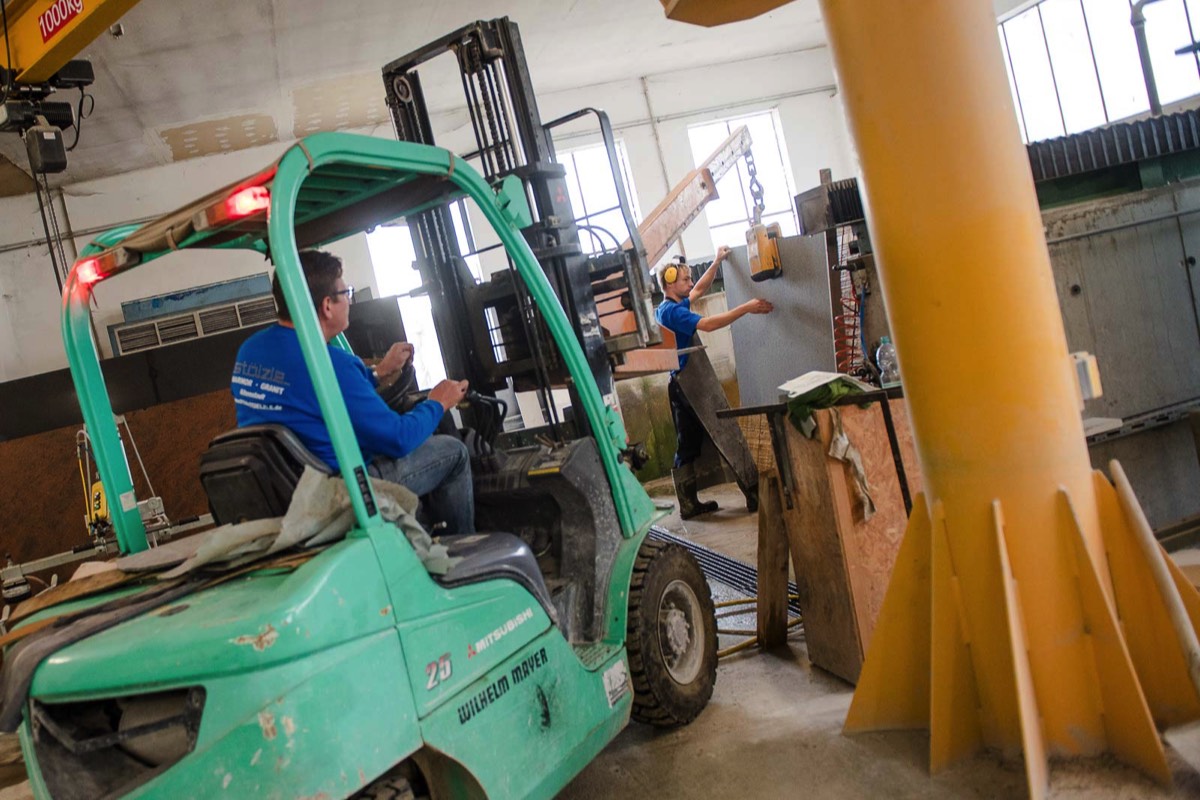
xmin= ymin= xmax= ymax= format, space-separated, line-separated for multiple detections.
xmin=559 ymin=486 xmax=1200 ymax=800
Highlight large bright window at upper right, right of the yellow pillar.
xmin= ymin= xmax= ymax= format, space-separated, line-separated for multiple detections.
xmin=997 ymin=0 xmax=1200 ymax=142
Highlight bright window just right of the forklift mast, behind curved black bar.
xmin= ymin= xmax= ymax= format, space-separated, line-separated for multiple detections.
xmin=557 ymin=139 xmax=642 ymax=253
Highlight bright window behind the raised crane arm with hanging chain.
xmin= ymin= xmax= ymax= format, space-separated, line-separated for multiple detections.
xmin=688 ymin=110 xmax=799 ymax=253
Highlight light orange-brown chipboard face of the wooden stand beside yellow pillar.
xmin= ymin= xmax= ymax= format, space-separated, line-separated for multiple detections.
xmin=816 ymin=403 xmax=920 ymax=652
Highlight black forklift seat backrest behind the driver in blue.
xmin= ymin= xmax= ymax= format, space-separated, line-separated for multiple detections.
xmin=200 ymin=425 xmax=331 ymax=525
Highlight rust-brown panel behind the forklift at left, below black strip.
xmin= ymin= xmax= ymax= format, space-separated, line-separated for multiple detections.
xmin=0 ymin=390 xmax=236 ymax=566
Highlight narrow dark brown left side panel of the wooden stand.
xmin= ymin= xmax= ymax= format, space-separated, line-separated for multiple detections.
xmin=784 ymin=425 xmax=863 ymax=684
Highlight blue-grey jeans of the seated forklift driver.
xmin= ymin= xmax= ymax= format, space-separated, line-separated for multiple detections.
xmin=367 ymin=434 xmax=475 ymax=536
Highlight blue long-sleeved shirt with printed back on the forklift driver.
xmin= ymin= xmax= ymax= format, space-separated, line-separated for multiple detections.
xmin=229 ymin=325 xmax=444 ymax=471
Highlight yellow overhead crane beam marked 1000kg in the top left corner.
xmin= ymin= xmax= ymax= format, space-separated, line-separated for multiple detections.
xmin=0 ymin=0 xmax=138 ymax=84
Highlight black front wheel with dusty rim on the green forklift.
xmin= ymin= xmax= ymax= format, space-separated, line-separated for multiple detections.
xmin=625 ymin=539 xmax=716 ymax=728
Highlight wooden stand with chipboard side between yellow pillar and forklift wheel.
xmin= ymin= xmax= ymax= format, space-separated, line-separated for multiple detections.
xmin=720 ymin=389 xmax=922 ymax=682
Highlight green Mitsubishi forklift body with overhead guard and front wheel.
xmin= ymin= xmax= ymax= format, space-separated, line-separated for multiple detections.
xmin=0 ymin=133 xmax=716 ymax=800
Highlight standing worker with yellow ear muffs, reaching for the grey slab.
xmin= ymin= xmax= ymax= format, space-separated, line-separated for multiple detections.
xmin=654 ymin=247 xmax=774 ymax=519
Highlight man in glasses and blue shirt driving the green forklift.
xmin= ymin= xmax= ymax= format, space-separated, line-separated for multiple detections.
xmin=230 ymin=251 xmax=475 ymax=534
